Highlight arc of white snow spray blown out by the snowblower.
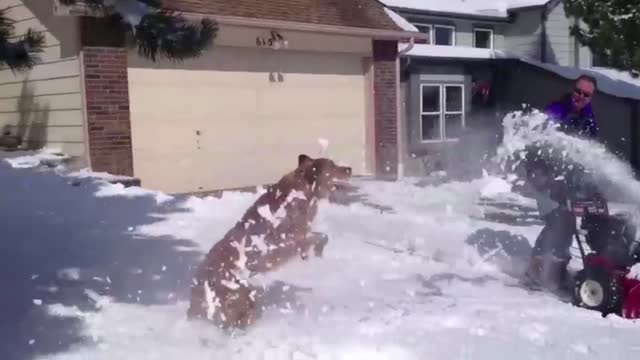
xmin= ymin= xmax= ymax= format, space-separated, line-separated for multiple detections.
xmin=493 ymin=110 xmax=640 ymax=205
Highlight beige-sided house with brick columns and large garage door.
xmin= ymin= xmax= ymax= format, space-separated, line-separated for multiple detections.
xmin=0 ymin=0 xmax=427 ymax=193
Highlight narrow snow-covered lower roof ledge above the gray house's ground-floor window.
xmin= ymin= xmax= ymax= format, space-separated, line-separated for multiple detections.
xmin=398 ymin=44 xmax=517 ymax=59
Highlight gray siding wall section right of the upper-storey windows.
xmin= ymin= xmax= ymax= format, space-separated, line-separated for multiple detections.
xmin=504 ymin=9 xmax=543 ymax=60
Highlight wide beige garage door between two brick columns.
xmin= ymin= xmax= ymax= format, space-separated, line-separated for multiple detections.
xmin=129 ymin=47 xmax=368 ymax=193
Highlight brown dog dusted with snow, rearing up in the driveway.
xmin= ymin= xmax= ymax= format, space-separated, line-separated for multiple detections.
xmin=187 ymin=154 xmax=351 ymax=328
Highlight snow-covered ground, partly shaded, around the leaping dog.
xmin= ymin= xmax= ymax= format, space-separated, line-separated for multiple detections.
xmin=0 ymin=111 xmax=640 ymax=360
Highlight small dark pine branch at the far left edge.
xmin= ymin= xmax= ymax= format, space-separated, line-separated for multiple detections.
xmin=0 ymin=10 xmax=45 ymax=72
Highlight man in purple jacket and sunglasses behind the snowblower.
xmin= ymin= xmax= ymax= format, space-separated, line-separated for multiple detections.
xmin=525 ymin=75 xmax=598 ymax=290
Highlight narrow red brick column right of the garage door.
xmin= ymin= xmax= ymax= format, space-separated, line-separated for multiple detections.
xmin=373 ymin=40 xmax=398 ymax=179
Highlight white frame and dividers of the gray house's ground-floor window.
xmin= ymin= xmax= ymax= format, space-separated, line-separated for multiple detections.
xmin=418 ymin=83 xmax=466 ymax=144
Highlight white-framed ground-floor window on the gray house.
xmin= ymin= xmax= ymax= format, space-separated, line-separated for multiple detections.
xmin=420 ymin=84 xmax=464 ymax=142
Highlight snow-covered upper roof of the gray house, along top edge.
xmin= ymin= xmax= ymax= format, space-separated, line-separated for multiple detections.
xmin=380 ymin=0 xmax=550 ymax=19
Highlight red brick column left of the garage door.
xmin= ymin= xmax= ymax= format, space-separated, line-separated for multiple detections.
xmin=82 ymin=47 xmax=133 ymax=176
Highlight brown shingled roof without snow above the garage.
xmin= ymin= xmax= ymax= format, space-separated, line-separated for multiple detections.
xmin=165 ymin=0 xmax=402 ymax=31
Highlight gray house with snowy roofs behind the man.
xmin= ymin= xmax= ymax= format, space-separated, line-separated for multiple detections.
xmin=382 ymin=0 xmax=640 ymax=180
